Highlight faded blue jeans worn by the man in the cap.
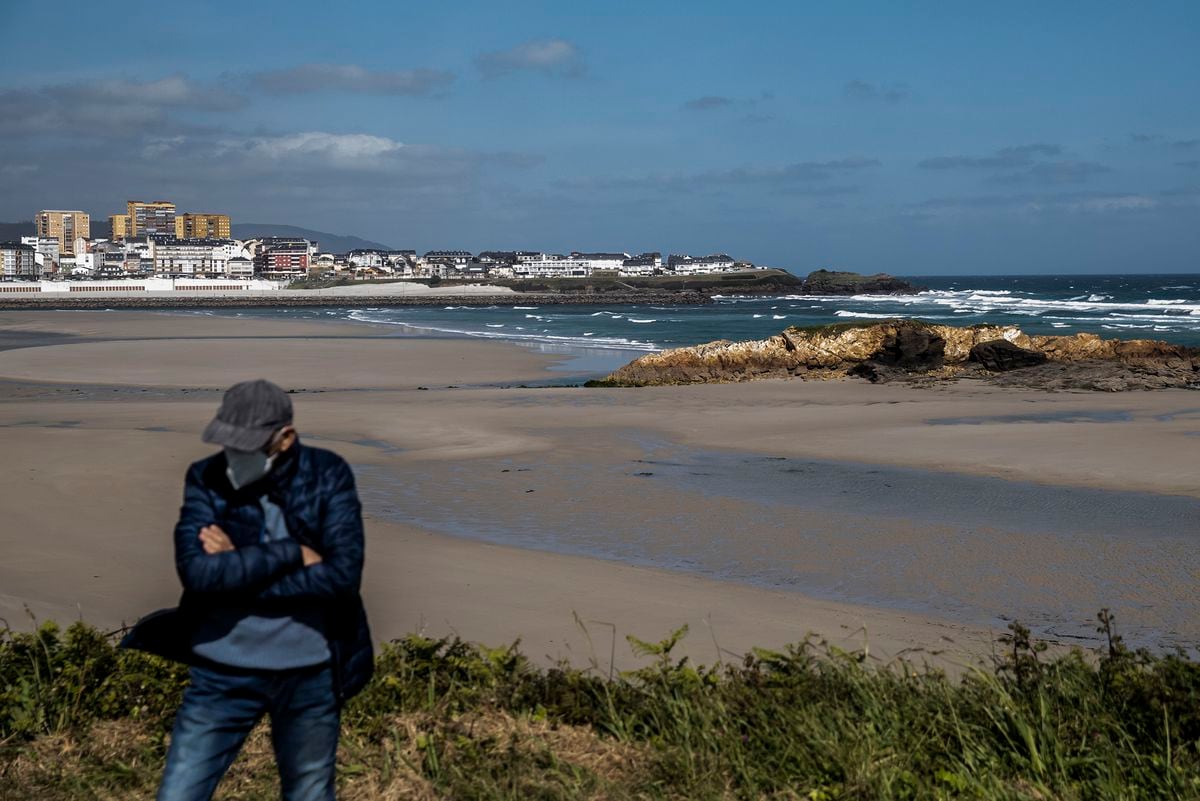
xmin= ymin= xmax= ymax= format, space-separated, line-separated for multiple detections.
xmin=158 ymin=664 xmax=341 ymax=801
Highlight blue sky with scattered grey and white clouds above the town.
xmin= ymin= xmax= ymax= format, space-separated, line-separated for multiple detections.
xmin=0 ymin=0 xmax=1200 ymax=275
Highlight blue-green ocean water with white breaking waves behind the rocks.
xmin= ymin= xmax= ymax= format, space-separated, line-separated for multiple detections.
xmin=211 ymin=275 xmax=1200 ymax=360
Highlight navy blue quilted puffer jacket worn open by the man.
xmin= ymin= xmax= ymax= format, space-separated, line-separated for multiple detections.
xmin=121 ymin=442 xmax=374 ymax=701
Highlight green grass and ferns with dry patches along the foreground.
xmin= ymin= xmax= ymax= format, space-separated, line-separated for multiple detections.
xmin=0 ymin=613 xmax=1200 ymax=800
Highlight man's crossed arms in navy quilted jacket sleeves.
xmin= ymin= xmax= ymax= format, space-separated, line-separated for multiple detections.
xmin=175 ymin=455 xmax=362 ymax=600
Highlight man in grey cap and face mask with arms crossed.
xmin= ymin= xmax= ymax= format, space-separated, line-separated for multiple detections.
xmin=124 ymin=380 xmax=373 ymax=801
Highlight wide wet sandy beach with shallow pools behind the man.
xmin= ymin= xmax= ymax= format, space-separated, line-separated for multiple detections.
xmin=0 ymin=312 xmax=1200 ymax=668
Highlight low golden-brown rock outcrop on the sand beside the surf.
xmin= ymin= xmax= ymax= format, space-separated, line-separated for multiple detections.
xmin=593 ymin=320 xmax=1200 ymax=392
